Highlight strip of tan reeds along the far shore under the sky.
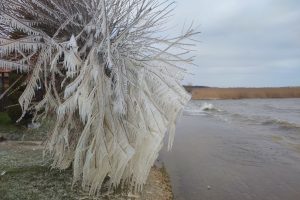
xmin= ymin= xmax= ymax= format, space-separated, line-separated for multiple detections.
xmin=185 ymin=86 xmax=300 ymax=100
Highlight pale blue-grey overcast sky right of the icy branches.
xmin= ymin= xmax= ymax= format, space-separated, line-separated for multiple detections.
xmin=172 ymin=0 xmax=300 ymax=87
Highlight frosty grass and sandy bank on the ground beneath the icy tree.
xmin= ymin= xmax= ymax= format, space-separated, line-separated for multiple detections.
xmin=0 ymin=138 xmax=173 ymax=200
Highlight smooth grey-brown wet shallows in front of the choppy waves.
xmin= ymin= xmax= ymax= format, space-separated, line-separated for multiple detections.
xmin=160 ymin=116 xmax=300 ymax=200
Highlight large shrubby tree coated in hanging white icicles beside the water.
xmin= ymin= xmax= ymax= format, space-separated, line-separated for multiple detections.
xmin=0 ymin=0 xmax=195 ymax=194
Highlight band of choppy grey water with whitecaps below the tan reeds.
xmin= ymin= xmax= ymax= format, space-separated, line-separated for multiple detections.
xmin=184 ymin=99 xmax=300 ymax=134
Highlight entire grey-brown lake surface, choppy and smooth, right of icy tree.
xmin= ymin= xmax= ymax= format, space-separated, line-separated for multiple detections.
xmin=161 ymin=99 xmax=300 ymax=200
